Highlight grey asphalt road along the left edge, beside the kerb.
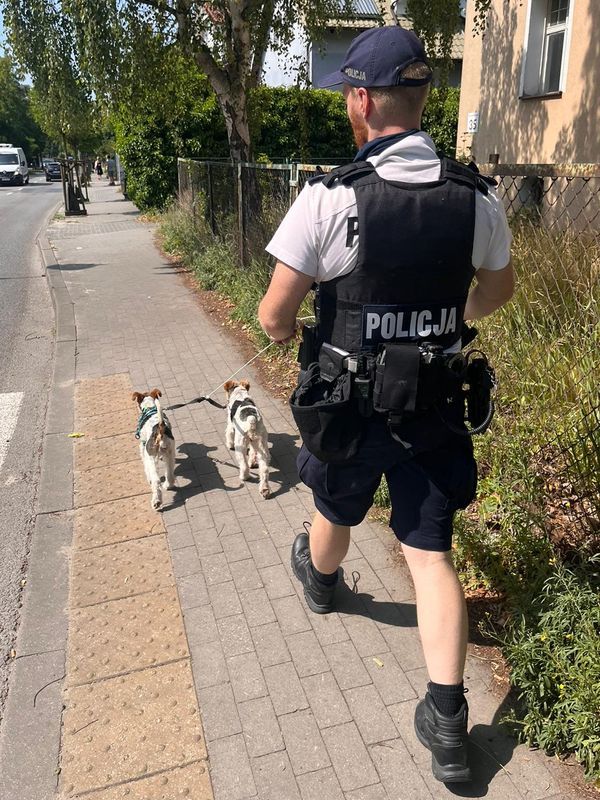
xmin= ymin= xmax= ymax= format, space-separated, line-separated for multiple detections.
xmin=0 ymin=177 xmax=62 ymax=719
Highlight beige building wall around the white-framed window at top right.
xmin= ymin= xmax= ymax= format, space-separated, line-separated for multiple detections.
xmin=457 ymin=0 xmax=600 ymax=164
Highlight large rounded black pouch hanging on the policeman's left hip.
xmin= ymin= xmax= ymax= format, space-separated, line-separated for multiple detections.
xmin=290 ymin=363 xmax=364 ymax=463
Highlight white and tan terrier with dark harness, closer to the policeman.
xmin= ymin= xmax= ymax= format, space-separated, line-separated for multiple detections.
xmin=223 ymin=381 xmax=271 ymax=498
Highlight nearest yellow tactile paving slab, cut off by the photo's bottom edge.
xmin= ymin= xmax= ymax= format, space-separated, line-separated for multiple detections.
xmin=67 ymin=762 xmax=213 ymax=800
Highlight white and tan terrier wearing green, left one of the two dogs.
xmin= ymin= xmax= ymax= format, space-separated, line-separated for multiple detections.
xmin=132 ymin=389 xmax=176 ymax=510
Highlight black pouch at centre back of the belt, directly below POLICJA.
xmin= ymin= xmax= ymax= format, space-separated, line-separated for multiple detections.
xmin=373 ymin=343 xmax=421 ymax=414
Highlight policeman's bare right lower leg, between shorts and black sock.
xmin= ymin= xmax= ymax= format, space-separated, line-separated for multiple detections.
xmin=400 ymin=538 xmax=468 ymax=685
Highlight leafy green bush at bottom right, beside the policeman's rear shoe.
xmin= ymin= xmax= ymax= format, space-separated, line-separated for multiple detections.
xmin=504 ymin=565 xmax=600 ymax=778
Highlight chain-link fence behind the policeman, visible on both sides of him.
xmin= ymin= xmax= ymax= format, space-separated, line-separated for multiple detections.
xmin=178 ymin=159 xmax=600 ymax=264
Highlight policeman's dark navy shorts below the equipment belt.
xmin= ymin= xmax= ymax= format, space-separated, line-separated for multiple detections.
xmin=297 ymin=418 xmax=477 ymax=552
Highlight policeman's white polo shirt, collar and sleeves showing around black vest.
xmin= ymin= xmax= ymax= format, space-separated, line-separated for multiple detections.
xmin=266 ymin=131 xmax=512 ymax=283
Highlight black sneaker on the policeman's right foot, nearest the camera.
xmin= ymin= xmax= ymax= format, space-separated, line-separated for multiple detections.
xmin=415 ymin=692 xmax=471 ymax=783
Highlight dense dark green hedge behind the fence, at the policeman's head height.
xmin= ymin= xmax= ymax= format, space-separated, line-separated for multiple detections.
xmin=115 ymin=83 xmax=459 ymax=210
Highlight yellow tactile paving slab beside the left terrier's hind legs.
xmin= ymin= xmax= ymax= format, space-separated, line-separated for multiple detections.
xmin=73 ymin=458 xmax=149 ymax=506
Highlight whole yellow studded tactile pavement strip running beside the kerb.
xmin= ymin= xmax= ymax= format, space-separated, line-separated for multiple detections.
xmin=60 ymin=375 xmax=213 ymax=800
